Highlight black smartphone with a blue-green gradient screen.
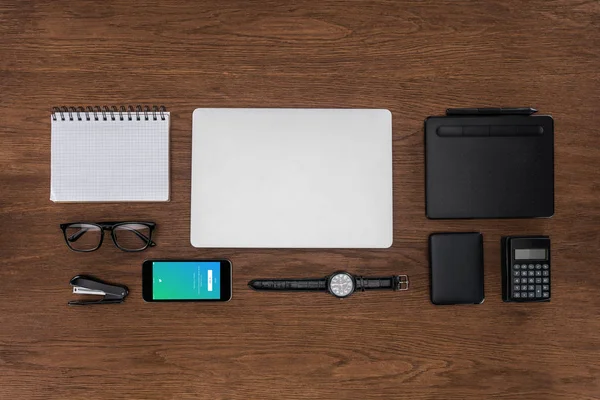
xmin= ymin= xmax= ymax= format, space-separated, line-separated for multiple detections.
xmin=142 ymin=260 xmax=231 ymax=301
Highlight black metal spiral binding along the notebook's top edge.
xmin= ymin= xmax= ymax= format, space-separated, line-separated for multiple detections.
xmin=52 ymin=105 xmax=167 ymax=121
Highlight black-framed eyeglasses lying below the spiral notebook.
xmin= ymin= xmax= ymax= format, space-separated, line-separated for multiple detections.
xmin=60 ymin=222 xmax=156 ymax=252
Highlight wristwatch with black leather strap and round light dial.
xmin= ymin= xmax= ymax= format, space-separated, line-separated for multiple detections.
xmin=248 ymin=271 xmax=408 ymax=299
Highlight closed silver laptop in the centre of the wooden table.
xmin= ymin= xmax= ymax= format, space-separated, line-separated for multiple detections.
xmin=191 ymin=108 xmax=393 ymax=248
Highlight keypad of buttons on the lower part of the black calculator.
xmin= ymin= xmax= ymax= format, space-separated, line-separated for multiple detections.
xmin=511 ymin=262 xmax=550 ymax=301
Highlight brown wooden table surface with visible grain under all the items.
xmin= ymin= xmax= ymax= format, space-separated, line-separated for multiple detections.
xmin=0 ymin=0 xmax=600 ymax=400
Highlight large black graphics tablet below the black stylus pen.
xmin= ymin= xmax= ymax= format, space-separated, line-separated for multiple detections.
xmin=425 ymin=115 xmax=554 ymax=219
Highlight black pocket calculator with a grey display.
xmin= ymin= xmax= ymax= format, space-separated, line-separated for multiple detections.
xmin=502 ymin=236 xmax=551 ymax=303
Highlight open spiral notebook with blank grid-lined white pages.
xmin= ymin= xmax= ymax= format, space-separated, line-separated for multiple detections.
xmin=50 ymin=106 xmax=170 ymax=202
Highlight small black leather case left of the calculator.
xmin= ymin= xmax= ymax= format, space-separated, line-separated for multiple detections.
xmin=429 ymin=233 xmax=485 ymax=305
